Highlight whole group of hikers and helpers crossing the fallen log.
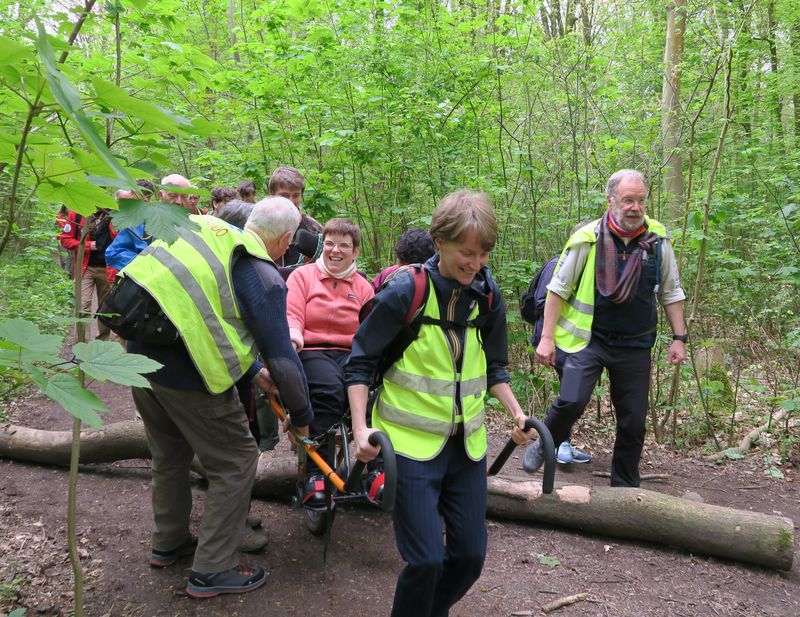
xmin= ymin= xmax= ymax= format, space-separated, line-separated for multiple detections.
xmin=54 ymin=167 xmax=687 ymax=617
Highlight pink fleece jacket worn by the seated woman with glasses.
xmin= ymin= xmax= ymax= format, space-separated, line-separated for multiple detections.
xmin=286 ymin=263 xmax=375 ymax=351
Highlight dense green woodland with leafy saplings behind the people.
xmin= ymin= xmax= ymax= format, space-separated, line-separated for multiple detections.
xmin=0 ymin=0 xmax=800 ymax=462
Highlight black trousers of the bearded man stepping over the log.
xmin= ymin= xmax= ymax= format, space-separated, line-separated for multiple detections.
xmin=544 ymin=339 xmax=650 ymax=486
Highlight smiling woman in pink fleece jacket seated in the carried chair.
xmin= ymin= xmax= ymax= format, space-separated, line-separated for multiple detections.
xmin=286 ymin=219 xmax=375 ymax=508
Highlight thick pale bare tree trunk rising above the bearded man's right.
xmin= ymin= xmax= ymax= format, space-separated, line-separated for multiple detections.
xmin=661 ymin=0 xmax=686 ymax=221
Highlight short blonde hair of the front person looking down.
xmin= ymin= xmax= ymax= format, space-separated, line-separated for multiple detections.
xmin=430 ymin=189 xmax=497 ymax=251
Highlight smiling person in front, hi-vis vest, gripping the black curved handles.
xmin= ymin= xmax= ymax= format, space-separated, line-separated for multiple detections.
xmin=345 ymin=190 xmax=535 ymax=617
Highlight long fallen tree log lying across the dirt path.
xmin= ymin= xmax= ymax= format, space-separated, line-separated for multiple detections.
xmin=0 ymin=421 xmax=794 ymax=570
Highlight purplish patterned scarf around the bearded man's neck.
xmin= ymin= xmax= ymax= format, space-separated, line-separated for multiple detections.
xmin=595 ymin=212 xmax=658 ymax=304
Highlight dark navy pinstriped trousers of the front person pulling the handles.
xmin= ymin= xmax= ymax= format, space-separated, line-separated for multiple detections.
xmin=391 ymin=435 xmax=487 ymax=617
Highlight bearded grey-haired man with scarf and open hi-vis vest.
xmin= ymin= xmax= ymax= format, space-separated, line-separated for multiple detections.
xmin=523 ymin=169 xmax=687 ymax=487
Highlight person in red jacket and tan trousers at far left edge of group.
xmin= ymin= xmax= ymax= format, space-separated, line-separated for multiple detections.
xmin=59 ymin=208 xmax=117 ymax=340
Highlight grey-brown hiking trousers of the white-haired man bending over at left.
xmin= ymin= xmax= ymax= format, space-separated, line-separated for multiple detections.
xmin=132 ymin=382 xmax=258 ymax=573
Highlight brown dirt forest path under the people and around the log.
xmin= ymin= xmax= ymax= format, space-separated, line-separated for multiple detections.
xmin=0 ymin=384 xmax=800 ymax=617
